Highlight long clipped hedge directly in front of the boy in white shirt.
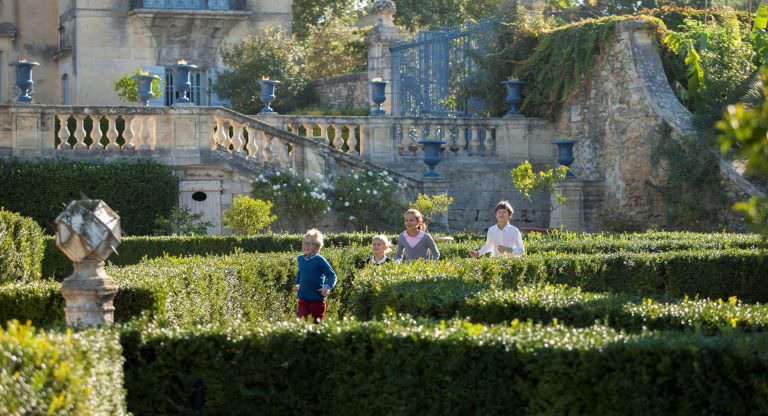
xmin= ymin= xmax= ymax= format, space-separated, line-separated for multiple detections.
xmin=347 ymin=250 xmax=768 ymax=319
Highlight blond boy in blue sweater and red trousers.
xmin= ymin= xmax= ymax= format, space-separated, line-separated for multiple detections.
xmin=293 ymin=228 xmax=336 ymax=322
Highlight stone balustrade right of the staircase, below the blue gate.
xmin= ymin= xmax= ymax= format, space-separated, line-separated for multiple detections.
xmin=259 ymin=115 xmax=554 ymax=164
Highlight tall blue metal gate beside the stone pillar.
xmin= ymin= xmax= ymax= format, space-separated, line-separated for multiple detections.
xmin=390 ymin=20 xmax=495 ymax=116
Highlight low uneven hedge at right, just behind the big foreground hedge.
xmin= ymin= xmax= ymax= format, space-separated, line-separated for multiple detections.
xmin=354 ymin=279 xmax=768 ymax=335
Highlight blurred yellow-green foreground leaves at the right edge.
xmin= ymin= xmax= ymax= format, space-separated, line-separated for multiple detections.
xmin=717 ymin=69 xmax=768 ymax=235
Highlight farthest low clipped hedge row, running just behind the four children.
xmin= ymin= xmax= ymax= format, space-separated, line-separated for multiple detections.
xmin=37 ymin=231 xmax=768 ymax=279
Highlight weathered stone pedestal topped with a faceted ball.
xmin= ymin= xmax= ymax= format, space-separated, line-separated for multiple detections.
xmin=56 ymin=199 xmax=121 ymax=326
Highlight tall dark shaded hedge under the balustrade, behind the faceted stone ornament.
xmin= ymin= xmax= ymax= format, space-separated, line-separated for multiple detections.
xmin=0 ymin=160 xmax=178 ymax=235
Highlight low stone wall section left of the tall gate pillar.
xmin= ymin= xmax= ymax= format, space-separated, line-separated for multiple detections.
xmin=315 ymin=72 xmax=370 ymax=108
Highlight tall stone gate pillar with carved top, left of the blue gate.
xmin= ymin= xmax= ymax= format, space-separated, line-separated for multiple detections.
xmin=365 ymin=0 xmax=403 ymax=114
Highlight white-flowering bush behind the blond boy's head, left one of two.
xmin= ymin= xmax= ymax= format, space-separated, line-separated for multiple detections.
xmin=251 ymin=171 xmax=331 ymax=232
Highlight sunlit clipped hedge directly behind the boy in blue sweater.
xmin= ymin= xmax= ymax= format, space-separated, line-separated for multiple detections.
xmin=7 ymin=248 xmax=368 ymax=326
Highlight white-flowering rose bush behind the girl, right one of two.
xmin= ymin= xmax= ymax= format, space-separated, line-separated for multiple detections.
xmin=333 ymin=170 xmax=405 ymax=230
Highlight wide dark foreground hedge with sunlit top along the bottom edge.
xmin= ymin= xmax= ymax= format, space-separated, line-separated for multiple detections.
xmin=122 ymin=318 xmax=768 ymax=415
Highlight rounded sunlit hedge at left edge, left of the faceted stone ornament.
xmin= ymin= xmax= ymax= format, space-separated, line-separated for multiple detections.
xmin=0 ymin=207 xmax=44 ymax=283
